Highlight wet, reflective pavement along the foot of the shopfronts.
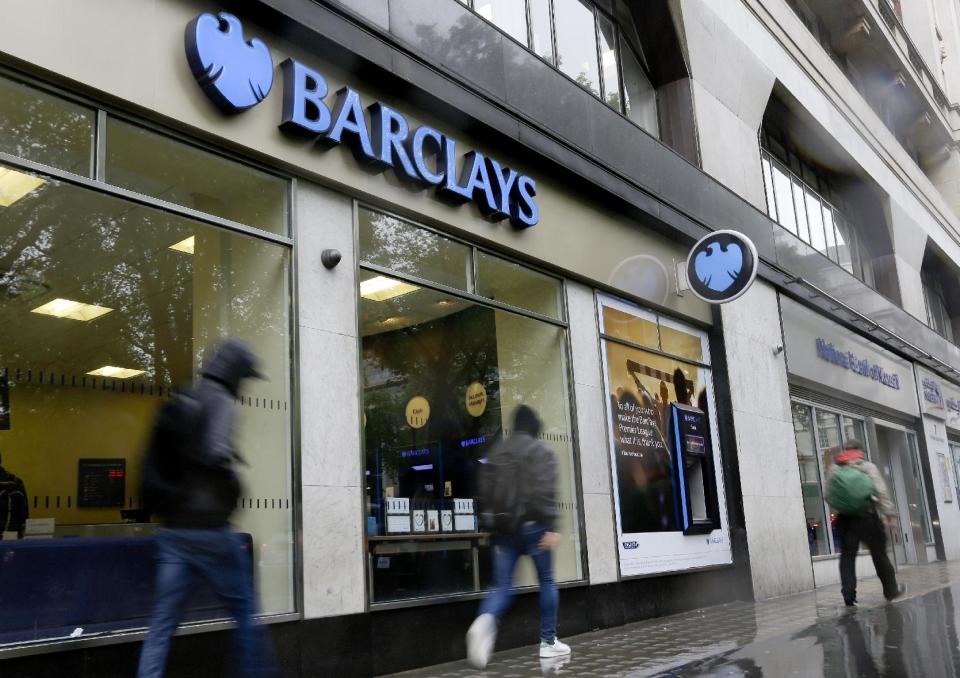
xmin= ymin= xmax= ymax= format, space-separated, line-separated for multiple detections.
xmin=386 ymin=563 xmax=960 ymax=678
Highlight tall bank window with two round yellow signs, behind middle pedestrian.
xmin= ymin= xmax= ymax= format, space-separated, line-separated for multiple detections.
xmin=359 ymin=209 xmax=583 ymax=604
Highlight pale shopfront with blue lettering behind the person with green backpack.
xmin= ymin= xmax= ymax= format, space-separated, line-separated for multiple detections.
xmin=780 ymin=296 xmax=937 ymax=586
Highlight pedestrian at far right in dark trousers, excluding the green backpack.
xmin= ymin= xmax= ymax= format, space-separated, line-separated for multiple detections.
xmin=824 ymin=439 xmax=904 ymax=607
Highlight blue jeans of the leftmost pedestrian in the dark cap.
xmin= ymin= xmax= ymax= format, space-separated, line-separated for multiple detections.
xmin=137 ymin=527 xmax=279 ymax=678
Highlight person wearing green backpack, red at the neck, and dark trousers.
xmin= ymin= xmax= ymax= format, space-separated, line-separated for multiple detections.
xmin=824 ymin=439 xmax=904 ymax=607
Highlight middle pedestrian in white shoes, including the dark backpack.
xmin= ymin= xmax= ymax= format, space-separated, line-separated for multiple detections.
xmin=467 ymin=405 xmax=570 ymax=669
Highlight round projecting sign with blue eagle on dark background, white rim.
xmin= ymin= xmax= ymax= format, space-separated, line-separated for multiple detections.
xmin=687 ymin=231 xmax=758 ymax=304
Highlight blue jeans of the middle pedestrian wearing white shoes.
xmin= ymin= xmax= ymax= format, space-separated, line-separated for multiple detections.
xmin=480 ymin=523 xmax=559 ymax=643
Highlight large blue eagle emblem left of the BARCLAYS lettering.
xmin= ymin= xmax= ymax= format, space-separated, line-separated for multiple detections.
xmin=185 ymin=12 xmax=273 ymax=113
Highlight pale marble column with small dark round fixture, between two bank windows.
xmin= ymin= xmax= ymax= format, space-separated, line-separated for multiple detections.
xmin=295 ymin=181 xmax=366 ymax=618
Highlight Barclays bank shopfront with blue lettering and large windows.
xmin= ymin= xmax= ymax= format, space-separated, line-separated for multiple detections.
xmin=0 ymin=2 xmax=749 ymax=675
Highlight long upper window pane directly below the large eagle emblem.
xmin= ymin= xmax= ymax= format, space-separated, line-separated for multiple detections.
xmin=105 ymin=116 xmax=289 ymax=235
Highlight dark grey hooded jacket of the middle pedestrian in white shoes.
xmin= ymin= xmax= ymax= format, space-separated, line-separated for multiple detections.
xmin=502 ymin=405 xmax=557 ymax=532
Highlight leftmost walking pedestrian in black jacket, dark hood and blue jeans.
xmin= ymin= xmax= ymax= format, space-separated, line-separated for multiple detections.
xmin=137 ymin=339 xmax=279 ymax=678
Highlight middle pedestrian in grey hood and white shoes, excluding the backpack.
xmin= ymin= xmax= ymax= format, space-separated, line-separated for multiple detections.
xmin=467 ymin=405 xmax=570 ymax=669
